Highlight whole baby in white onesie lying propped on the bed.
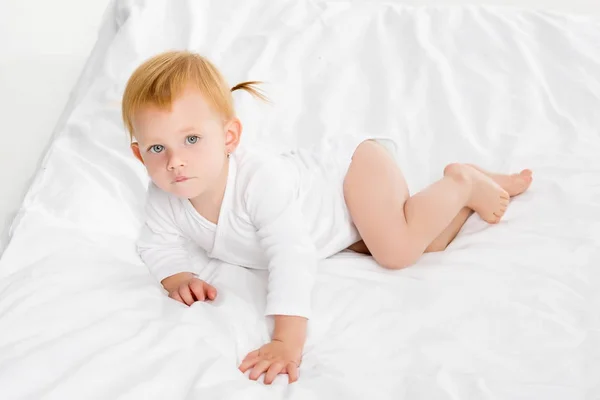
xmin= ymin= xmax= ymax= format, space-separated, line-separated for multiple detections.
xmin=122 ymin=51 xmax=532 ymax=384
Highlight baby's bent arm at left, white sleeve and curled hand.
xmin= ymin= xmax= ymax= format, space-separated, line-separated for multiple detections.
xmin=137 ymin=185 xmax=217 ymax=305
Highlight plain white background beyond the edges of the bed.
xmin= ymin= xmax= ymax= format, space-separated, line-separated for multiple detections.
xmin=0 ymin=0 xmax=600 ymax=251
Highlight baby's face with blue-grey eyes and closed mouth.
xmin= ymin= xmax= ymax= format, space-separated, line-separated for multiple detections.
xmin=132 ymin=89 xmax=237 ymax=199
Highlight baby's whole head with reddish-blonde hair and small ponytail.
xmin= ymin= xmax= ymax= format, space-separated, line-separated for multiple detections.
xmin=122 ymin=51 xmax=264 ymax=199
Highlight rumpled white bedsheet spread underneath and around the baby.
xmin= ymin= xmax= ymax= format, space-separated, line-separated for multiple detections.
xmin=0 ymin=0 xmax=600 ymax=400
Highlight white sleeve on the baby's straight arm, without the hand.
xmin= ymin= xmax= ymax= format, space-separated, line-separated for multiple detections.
xmin=245 ymin=159 xmax=318 ymax=318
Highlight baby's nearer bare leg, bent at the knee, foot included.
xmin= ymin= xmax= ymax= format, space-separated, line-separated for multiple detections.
xmin=344 ymin=141 xmax=508 ymax=269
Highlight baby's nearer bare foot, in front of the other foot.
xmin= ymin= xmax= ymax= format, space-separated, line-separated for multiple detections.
xmin=444 ymin=164 xmax=510 ymax=224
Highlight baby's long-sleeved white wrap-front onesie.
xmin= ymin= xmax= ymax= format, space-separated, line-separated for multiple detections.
xmin=138 ymin=139 xmax=393 ymax=318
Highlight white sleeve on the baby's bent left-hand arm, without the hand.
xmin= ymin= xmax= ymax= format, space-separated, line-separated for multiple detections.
xmin=137 ymin=184 xmax=195 ymax=282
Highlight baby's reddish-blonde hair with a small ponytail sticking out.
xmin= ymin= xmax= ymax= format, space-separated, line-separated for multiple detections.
xmin=121 ymin=51 xmax=268 ymax=141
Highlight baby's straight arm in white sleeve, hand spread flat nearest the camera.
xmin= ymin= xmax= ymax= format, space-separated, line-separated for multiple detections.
xmin=240 ymin=161 xmax=317 ymax=383
